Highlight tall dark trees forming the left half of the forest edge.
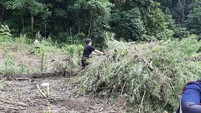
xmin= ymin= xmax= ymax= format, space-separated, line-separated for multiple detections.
xmin=0 ymin=0 xmax=112 ymax=45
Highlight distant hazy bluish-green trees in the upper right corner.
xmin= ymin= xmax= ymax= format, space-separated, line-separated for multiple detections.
xmin=155 ymin=0 xmax=201 ymax=36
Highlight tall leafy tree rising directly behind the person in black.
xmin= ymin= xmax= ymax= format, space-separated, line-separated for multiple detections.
xmin=70 ymin=0 xmax=112 ymax=47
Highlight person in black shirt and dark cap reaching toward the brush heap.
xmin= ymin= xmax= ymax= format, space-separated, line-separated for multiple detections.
xmin=81 ymin=38 xmax=104 ymax=69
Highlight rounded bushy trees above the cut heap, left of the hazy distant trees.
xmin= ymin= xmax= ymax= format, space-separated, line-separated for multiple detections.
xmin=110 ymin=0 xmax=167 ymax=41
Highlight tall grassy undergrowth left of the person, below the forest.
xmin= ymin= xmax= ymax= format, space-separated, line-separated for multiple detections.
xmin=0 ymin=25 xmax=83 ymax=75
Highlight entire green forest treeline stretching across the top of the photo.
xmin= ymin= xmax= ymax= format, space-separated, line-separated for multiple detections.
xmin=0 ymin=0 xmax=201 ymax=44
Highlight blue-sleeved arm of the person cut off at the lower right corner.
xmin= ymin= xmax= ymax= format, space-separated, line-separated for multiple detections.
xmin=181 ymin=84 xmax=201 ymax=113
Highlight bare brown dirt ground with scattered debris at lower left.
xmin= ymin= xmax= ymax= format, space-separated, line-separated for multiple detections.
xmin=0 ymin=77 xmax=123 ymax=113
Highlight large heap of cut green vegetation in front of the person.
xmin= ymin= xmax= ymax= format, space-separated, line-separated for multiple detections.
xmin=80 ymin=36 xmax=201 ymax=113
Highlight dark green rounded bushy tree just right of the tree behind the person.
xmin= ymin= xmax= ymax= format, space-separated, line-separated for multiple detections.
xmin=110 ymin=8 xmax=145 ymax=41
